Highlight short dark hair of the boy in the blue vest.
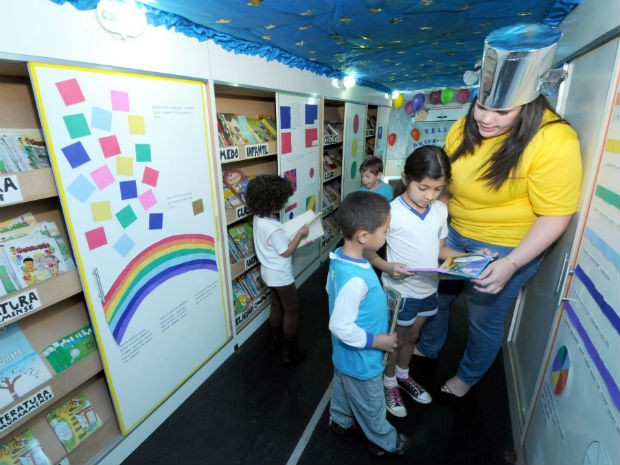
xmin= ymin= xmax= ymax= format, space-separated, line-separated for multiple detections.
xmin=336 ymin=191 xmax=390 ymax=239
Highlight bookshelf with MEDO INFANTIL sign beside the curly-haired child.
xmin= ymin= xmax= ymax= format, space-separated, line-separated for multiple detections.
xmin=212 ymin=84 xmax=278 ymax=332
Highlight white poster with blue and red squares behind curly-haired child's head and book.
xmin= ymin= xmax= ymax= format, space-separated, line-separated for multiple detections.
xmin=277 ymin=93 xmax=322 ymax=221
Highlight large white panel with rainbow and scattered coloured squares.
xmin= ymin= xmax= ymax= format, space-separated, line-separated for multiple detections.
xmin=30 ymin=63 xmax=231 ymax=434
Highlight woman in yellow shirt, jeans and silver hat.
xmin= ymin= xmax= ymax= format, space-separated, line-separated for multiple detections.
xmin=415 ymin=25 xmax=581 ymax=397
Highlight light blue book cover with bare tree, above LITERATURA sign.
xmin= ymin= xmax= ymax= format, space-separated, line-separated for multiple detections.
xmin=0 ymin=323 xmax=52 ymax=408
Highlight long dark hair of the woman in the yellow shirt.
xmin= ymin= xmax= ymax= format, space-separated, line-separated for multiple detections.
xmin=450 ymin=95 xmax=568 ymax=190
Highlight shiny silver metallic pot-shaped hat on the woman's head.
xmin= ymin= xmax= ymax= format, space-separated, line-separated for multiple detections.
xmin=478 ymin=24 xmax=566 ymax=110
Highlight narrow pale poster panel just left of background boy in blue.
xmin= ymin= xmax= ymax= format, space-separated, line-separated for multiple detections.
xmin=342 ymin=102 xmax=366 ymax=198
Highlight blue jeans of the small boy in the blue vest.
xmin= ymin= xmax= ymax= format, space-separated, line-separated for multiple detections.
xmin=329 ymin=369 xmax=398 ymax=452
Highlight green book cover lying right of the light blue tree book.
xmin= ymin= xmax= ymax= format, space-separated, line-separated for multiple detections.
xmin=41 ymin=325 xmax=97 ymax=373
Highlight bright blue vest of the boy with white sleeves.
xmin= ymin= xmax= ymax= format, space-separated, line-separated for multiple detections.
xmin=327 ymin=249 xmax=388 ymax=380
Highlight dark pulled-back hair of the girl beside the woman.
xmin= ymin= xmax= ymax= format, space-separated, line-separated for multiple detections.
xmin=394 ymin=145 xmax=452 ymax=197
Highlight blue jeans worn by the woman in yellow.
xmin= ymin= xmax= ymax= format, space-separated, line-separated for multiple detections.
xmin=416 ymin=228 xmax=543 ymax=386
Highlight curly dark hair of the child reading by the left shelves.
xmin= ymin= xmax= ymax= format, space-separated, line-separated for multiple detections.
xmin=245 ymin=174 xmax=293 ymax=216
